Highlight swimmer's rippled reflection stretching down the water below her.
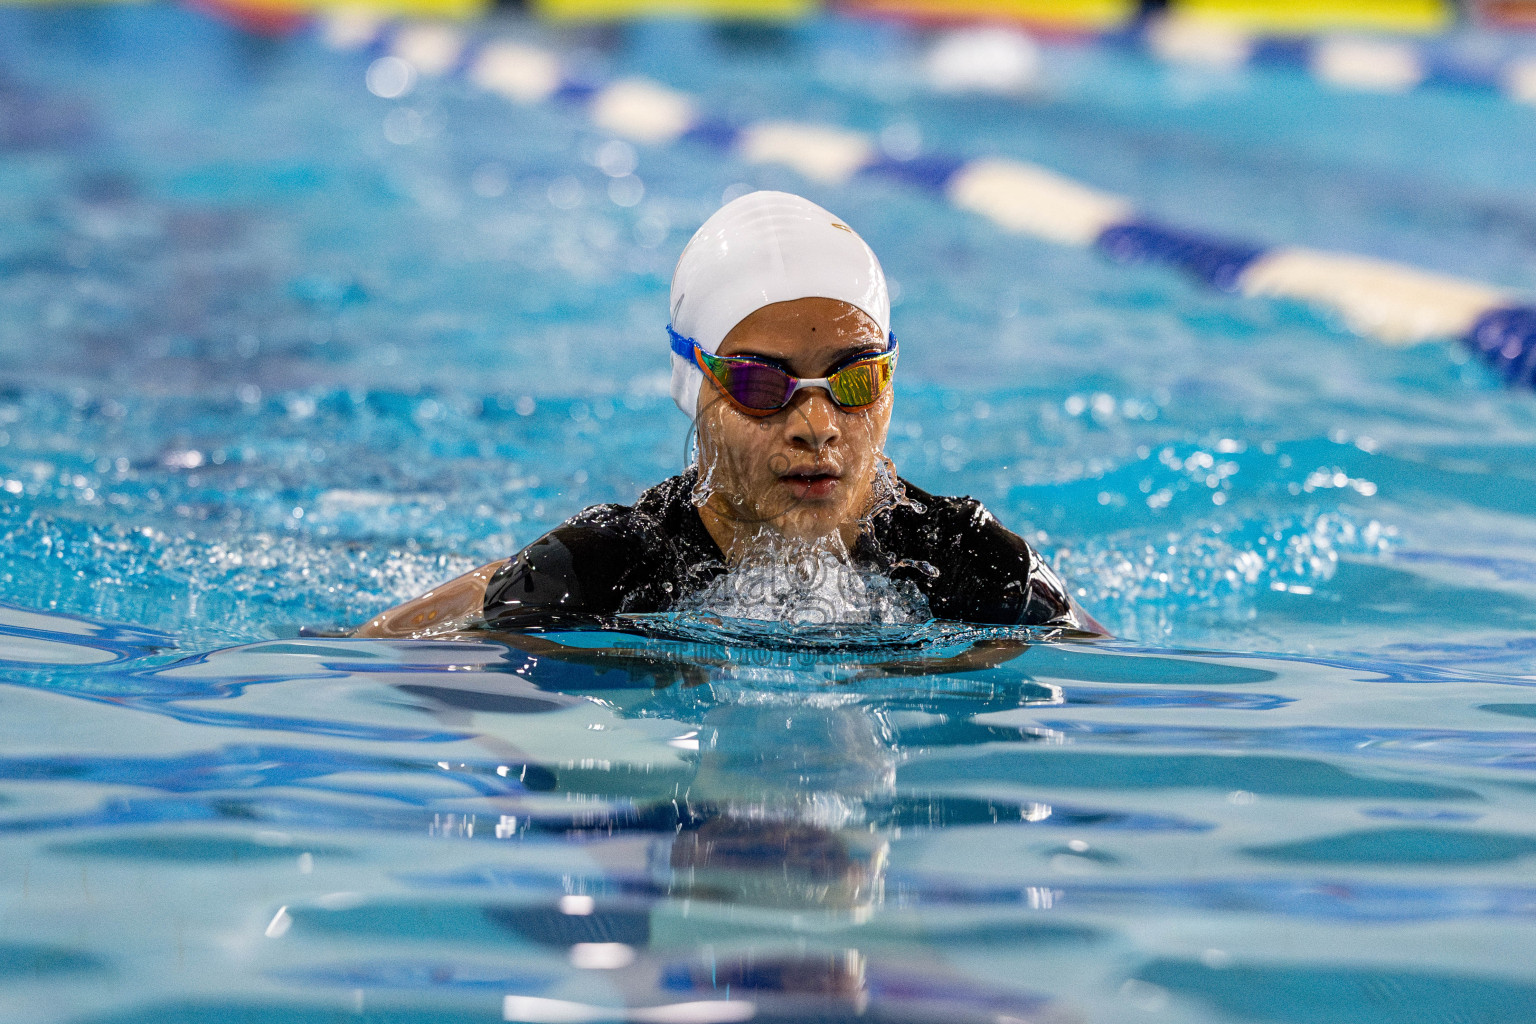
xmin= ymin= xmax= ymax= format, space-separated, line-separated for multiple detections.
xmin=396 ymin=634 xmax=1069 ymax=1021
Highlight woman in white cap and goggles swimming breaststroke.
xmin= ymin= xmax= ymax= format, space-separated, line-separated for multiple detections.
xmin=356 ymin=192 xmax=1103 ymax=637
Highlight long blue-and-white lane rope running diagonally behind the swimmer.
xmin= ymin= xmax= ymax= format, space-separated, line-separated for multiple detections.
xmin=319 ymin=11 xmax=1536 ymax=387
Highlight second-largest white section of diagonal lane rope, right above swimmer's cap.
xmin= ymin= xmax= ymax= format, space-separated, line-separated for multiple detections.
xmin=949 ymin=158 xmax=1132 ymax=246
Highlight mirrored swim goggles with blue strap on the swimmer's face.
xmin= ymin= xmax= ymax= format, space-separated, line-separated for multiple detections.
xmin=667 ymin=324 xmax=897 ymax=416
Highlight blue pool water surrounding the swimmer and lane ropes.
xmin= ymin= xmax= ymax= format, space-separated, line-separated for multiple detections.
xmin=0 ymin=8 xmax=1536 ymax=1024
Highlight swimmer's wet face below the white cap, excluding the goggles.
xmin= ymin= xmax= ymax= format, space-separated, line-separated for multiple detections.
xmin=697 ymin=298 xmax=892 ymax=545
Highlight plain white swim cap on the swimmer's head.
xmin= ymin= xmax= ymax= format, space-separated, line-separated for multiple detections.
xmin=671 ymin=192 xmax=891 ymax=419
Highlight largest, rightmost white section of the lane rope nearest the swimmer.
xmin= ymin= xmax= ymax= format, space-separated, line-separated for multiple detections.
xmin=1238 ymin=249 xmax=1513 ymax=345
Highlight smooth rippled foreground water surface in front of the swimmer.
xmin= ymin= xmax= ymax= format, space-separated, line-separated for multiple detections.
xmin=0 ymin=609 xmax=1536 ymax=1024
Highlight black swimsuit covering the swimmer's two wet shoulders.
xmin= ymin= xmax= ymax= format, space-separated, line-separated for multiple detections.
xmin=485 ymin=470 xmax=1086 ymax=628
